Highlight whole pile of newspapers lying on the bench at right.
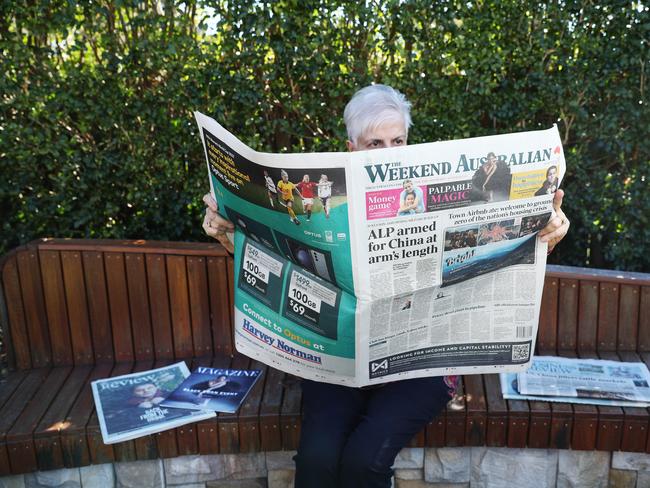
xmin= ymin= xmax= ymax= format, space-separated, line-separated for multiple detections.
xmin=501 ymin=356 xmax=650 ymax=407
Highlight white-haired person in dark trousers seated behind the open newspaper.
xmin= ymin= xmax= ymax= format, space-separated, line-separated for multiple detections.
xmin=203 ymin=85 xmax=569 ymax=488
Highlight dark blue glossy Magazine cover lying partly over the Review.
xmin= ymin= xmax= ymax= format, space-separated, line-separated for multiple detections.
xmin=161 ymin=366 xmax=262 ymax=413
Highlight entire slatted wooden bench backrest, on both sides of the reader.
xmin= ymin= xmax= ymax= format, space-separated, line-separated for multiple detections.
xmin=0 ymin=239 xmax=650 ymax=369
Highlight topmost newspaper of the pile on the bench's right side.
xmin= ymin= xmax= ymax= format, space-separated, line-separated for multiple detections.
xmin=517 ymin=356 xmax=650 ymax=402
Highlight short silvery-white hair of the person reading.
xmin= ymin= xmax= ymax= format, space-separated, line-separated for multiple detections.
xmin=343 ymin=85 xmax=411 ymax=144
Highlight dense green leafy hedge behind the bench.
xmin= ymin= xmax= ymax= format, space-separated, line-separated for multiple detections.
xmin=0 ymin=0 xmax=650 ymax=271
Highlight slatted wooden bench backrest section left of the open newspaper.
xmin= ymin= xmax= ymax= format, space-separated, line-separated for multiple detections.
xmin=0 ymin=239 xmax=233 ymax=369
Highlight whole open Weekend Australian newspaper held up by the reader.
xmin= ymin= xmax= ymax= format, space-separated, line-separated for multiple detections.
xmin=195 ymin=112 xmax=566 ymax=386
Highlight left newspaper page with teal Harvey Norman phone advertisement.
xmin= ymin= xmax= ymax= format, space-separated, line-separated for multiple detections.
xmin=196 ymin=113 xmax=357 ymax=384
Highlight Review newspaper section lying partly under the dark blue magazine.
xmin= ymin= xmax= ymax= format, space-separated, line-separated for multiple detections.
xmin=92 ymin=362 xmax=215 ymax=444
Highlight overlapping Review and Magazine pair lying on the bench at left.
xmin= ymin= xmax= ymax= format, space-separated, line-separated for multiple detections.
xmin=92 ymin=362 xmax=261 ymax=444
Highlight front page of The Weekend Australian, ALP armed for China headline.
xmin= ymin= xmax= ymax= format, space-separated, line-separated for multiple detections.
xmin=350 ymin=127 xmax=565 ymax=384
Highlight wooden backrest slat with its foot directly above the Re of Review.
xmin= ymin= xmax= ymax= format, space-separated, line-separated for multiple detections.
xmin=81 ymin=251 xmax=115 ymax=363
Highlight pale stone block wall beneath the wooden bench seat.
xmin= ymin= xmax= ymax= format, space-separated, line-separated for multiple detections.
xmin=0 ymin=447 xmax=650 ymax=488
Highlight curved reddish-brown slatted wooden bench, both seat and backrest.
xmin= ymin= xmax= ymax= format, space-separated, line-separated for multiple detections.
xmin=0 ymin=239 xmax=650 ymax=476
